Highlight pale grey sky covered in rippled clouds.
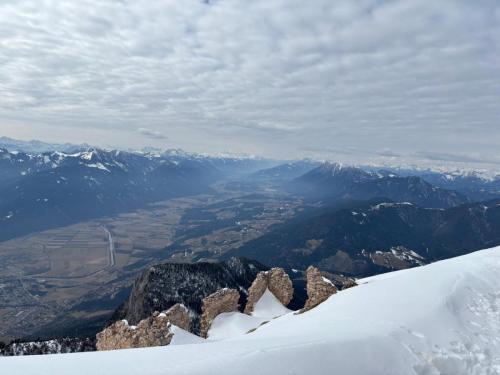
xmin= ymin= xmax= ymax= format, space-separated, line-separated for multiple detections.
xmin=0 ymin=0 xmax=500 ymax=164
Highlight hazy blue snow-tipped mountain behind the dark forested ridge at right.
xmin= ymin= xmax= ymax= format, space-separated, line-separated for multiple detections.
xmin=292 ymin=163 xmax=468 ymax=208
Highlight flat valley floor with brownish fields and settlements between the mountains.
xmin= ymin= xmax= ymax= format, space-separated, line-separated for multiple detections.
xmin=0 ymin=183 xmax=304 ymax=341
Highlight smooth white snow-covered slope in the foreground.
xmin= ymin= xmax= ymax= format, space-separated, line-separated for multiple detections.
xmin=0 ymin=248 xmax=500 ymax=375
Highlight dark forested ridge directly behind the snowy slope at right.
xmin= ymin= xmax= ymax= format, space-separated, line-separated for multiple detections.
xmin=228 ymin=200 xmax=500 ymax=276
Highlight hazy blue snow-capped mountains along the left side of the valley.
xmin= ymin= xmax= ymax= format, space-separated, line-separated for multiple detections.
xmin=0 ymin=149 xmax=221 ymax=240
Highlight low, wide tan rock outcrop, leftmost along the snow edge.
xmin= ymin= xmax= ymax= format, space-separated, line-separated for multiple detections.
xmin=96 ymin=304 xmax=189 ymax=351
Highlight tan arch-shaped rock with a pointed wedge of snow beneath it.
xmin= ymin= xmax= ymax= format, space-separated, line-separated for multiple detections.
xmin=245 ymin=268 xmax=293 ymax=314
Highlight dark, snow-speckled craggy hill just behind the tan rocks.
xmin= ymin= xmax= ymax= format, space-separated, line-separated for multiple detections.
xmin=110 ymin=258 xmax=268 ymax=332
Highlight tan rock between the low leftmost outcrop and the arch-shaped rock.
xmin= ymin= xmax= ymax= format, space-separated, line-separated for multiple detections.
xmin=200 ymin=288 xmax=240 ymax=338
